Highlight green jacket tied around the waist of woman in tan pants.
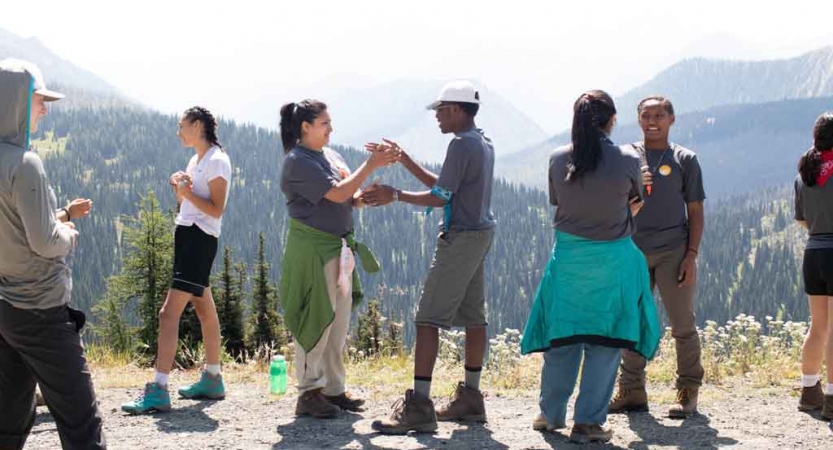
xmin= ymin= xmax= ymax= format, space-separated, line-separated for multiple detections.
xmin=281 ymin=219 xmax=379 ymax=351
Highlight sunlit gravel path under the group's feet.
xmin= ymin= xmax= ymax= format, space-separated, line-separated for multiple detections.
xmin=26 ymin=384 xmax=833 ymax=450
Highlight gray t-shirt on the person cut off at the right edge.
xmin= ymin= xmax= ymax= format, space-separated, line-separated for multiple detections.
xmin=795 ymin=175 xmax=833 ymax=250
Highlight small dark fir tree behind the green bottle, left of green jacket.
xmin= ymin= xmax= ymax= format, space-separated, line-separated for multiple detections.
xmin=247 ymin=233 xmax=286 ymax=350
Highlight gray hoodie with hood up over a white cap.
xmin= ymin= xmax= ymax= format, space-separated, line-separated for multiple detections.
xmin=0 ymin=62 xmax=75 ymax=309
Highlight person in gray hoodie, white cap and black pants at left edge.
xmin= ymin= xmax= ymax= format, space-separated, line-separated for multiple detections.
xmin=0 ymin=59 xmax=106 ymax=449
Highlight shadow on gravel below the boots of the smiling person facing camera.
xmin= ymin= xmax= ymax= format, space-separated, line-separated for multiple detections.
xmin=628 ymin=413 xmax=738 ymax=450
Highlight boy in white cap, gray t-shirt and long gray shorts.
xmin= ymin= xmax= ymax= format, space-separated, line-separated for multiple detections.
xmin=363 ymin=81 xmax=495 ymax=434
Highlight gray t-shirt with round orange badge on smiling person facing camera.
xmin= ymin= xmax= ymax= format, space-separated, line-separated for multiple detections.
xmin=632 ymin=142 xmax=706 ymax=253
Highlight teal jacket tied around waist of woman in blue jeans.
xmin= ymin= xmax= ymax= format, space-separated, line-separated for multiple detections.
xmin=521 ymin=231 xmax=661 ymax=359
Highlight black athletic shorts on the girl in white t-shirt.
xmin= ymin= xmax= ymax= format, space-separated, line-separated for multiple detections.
xmin=171 ymin=225 xmax=217 ymax=297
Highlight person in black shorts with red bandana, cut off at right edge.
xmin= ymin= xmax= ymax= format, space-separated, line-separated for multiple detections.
xmin=795 ymin=112 xmax=833 ymax=420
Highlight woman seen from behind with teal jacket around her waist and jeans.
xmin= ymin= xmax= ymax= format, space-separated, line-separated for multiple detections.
xmin=521 ymin=91 xmax=661 ymax=443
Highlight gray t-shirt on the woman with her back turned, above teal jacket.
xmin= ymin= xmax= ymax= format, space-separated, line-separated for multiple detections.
xmin=549 ymin=137 xmax=642 ymax=241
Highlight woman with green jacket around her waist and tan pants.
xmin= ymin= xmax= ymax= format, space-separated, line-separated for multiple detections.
xmin=280 ymin=100 xmax=399 ymax=418
